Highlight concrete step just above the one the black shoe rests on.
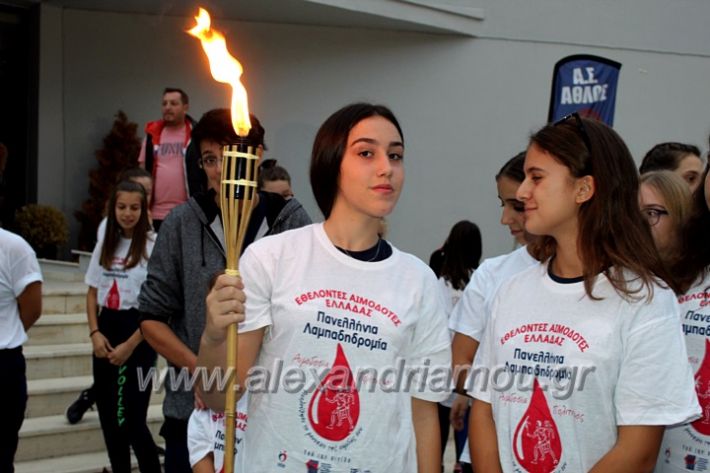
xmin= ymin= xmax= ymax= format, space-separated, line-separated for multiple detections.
xmin=25 ymin=376 xmax=165 ymax=419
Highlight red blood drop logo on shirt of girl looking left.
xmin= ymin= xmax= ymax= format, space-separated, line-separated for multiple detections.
xmin=513 ymin=378 xmax=562 ymax=473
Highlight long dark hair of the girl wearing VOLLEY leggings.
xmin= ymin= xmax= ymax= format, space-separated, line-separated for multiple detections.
xmin=99 ymin=181 xmax=150 ymax=269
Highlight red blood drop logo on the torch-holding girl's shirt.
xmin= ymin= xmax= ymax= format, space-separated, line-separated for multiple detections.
xmin=308 ymin=343 xmax=360 ymax=442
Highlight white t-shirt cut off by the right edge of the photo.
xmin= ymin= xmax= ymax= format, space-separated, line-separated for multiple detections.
xmin=656 ymin=275 xmax=710 ymax=472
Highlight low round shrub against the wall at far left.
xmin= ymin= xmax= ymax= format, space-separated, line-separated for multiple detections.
xmin=15 ymin=204 xmax=69 ymax=259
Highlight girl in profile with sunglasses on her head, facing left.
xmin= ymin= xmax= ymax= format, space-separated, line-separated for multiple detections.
xmin=469 ymin=114 xmax=699 ymax=473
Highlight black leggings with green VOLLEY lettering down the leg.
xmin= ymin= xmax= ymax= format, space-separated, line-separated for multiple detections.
xmin=93 ymin=309 xmax=160 ymax=473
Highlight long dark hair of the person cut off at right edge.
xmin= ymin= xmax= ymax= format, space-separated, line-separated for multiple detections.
xmin=671 ymin=168 xmax=710 ymax=294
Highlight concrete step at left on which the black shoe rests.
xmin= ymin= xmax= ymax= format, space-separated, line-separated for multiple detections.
xmin=15 ymin=405 xmax=163 ymax=460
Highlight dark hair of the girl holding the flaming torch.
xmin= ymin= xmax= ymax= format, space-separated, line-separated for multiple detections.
xmin=310 ymin=103 xmax=404 ymax=218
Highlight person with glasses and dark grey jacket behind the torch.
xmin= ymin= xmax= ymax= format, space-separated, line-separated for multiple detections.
xmin=139 ymin=109 xmax=311 ymax=471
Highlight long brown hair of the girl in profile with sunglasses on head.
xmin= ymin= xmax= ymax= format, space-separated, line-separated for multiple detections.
xmin=530 ymin=117 xmax=676 ymax=299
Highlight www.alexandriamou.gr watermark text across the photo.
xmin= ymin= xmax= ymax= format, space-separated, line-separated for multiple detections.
xmin=137 ymin=359 xmax=596 ymax=400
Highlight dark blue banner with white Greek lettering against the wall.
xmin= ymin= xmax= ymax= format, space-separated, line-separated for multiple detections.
xmin=547 ymin=54 xmax=621 ymax=126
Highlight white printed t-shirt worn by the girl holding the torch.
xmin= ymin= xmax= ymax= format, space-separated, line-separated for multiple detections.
xmin=240 ymin=224 xmax=451 ymax=473
